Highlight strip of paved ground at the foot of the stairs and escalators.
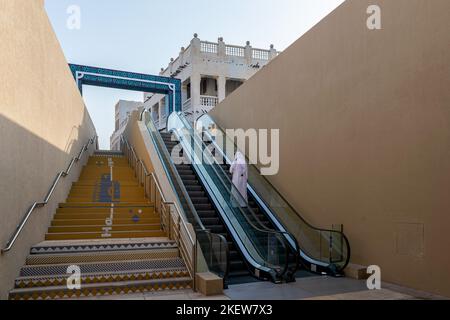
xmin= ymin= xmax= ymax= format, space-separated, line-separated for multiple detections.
xmin=75 ymin=277 xmax=445 ymax=300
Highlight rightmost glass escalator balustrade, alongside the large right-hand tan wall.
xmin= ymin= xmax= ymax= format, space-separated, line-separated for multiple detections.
xmin=195 ymin=114 xmax=350 ymax=276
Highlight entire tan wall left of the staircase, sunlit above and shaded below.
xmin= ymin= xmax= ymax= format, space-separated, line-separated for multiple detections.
xmin=0 ymin=0 xmax=95 ymax=299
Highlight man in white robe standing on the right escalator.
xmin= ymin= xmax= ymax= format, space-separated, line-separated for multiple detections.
xmin=230 ymin=151 xmax=248 ymax=207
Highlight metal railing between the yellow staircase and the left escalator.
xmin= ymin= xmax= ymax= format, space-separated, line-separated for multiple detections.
xmin=121 ymin=136 xmax=197 ymax=284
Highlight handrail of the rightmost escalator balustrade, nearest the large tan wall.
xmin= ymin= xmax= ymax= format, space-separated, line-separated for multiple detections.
xmin=196 ymin=114 xmax=351 ymax=270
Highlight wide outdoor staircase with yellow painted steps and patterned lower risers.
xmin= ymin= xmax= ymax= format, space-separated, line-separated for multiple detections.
xmin=9 ymin=152 xmax=192 ymax=300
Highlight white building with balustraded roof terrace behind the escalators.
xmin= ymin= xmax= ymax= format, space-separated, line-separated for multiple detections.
xmin=144 ymin=34 xmax=278 ymax=129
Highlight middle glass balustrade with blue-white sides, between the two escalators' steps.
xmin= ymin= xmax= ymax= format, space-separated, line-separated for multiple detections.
xmin=164 ymin=113 xmax=295 ymax=282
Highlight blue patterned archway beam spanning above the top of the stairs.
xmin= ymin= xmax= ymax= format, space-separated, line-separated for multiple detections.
xmin=69 ymin=64 xmax=181 ymax=114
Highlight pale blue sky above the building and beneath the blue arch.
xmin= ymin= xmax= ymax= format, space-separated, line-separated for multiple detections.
xmin=45 ymin=0 xmax=344 ymax=149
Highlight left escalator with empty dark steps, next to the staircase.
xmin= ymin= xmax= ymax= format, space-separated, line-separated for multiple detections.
xmin=144 ymin=111 xmax=299 ymax=284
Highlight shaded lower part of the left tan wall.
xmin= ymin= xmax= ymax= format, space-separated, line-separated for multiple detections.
xmin=0 ymin=110 xmax=95 ymax=299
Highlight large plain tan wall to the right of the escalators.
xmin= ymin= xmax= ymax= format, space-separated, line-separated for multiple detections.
xmin=211 ymin=0 xmax=450 ymax=296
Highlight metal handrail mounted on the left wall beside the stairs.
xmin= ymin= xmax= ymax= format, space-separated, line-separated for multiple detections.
xmin=1 ymin=135 xmax=98 ymax=255
